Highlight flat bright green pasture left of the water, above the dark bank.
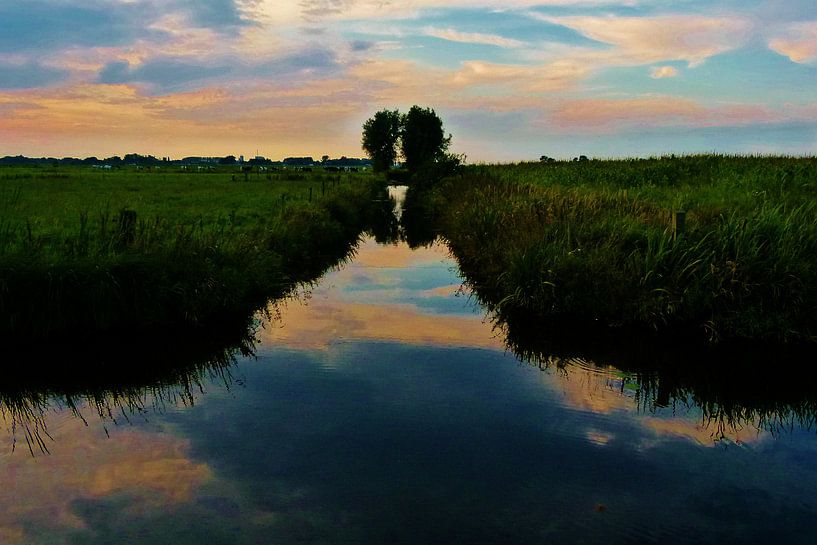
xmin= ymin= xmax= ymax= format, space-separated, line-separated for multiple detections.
xmin=0 ymin=167 xmax=366 ymax=256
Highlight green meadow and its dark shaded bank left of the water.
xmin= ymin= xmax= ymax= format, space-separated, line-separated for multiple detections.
xmin=0 ymin=167 xmax=379 ymax=338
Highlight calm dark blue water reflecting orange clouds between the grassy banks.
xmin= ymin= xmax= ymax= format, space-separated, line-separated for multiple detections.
xmin=0 ymin=189 xmax=817 ymax=545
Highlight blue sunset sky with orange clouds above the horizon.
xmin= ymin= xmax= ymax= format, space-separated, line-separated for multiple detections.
xmin=0 ymin=0 xmax=817 ymax=163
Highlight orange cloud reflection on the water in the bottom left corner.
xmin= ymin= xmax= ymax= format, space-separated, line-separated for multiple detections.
xmin=0 ymin=413 xmax=212 ymax=543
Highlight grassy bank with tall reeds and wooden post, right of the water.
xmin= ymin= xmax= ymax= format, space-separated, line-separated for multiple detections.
xmin=425 ymin=156 xmax=817 ymax=342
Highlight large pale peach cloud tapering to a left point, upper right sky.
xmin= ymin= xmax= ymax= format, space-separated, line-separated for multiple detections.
xmin=531 ymin=13 xmax=753 ymax=66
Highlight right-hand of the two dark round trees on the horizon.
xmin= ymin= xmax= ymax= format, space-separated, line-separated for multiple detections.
xmin=401 ymin=106 xmax=451 ymax=172
